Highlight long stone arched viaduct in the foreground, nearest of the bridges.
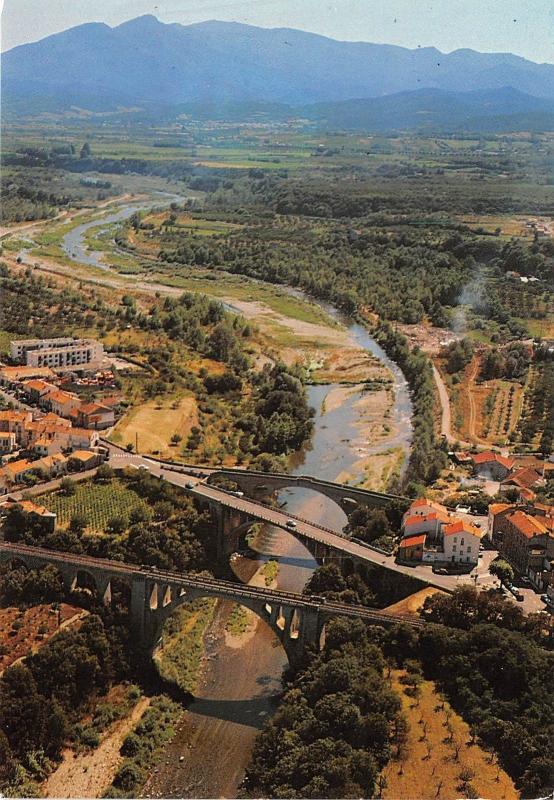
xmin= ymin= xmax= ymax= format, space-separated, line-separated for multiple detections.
xmin=0 ymin=542 xmax=425 ymax=662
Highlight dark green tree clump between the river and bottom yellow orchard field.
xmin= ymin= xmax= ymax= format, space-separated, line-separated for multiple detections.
xmin=243 ymin=620 xmax=403 ymax=797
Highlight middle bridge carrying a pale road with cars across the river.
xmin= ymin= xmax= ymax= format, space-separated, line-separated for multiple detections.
xmin=104 ymin=449 xmax=471 ymax=592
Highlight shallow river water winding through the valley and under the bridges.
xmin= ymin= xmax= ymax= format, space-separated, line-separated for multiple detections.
xmin=57 ymin=198 xmax=412 ymax=798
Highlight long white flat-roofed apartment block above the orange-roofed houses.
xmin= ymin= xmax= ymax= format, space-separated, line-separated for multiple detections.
xmin=10 ymin=337 xmax=104 ymax=372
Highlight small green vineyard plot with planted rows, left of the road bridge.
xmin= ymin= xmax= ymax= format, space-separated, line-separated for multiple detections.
xmin=40 ymin=479 xmax=148 ymax=533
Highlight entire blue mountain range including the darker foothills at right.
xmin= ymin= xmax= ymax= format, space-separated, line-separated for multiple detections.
xmin=2 ymin=15 xmax=554 ymax=130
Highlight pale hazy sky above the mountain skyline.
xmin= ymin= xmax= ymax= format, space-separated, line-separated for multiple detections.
xmin=0 ymin=0 xmax=554 ymax=63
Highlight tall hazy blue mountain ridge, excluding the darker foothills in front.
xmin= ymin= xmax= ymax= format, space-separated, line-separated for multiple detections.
xmin=2 ymin=14 xmax=554 ymax=114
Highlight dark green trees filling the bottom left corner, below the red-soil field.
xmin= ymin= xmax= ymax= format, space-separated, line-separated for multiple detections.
xmin=0 ymin=615 xmax=133 ymax=797
